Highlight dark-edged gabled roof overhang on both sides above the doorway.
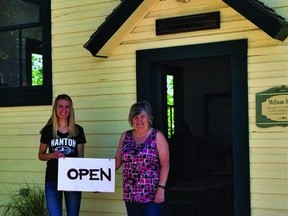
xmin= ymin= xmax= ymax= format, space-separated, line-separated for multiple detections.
xmin=84 ymin=0 xmax=288 ymax=58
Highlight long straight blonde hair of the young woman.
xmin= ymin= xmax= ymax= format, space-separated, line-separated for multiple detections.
xmin=40 ymin=94 xmax=78 ymax=137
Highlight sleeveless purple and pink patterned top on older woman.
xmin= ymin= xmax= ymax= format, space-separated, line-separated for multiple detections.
xmin=121 ymin=128 xmax=160 ymax=203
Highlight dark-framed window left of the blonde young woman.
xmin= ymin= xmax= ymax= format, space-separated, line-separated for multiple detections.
xmin=0 ymin=0 xmax=52 ymax=107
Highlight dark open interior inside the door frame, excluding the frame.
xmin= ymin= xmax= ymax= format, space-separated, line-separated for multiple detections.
xmin=161 ymin=56 xmax=234 ymax=216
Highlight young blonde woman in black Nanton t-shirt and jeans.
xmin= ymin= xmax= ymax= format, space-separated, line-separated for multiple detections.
xmin=38 ymin=94 xmax=86 ymax=216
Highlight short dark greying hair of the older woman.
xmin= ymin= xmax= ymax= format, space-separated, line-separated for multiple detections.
xmin=128 ymin=100 xmax=153 ymax=126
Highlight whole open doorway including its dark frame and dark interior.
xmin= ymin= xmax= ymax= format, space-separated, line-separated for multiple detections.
xmin=137 ymin=40 xmax=250 ymax=216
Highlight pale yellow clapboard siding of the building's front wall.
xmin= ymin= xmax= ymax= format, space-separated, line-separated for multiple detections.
xmin=0 ymin=0 xmax=288 ymax=216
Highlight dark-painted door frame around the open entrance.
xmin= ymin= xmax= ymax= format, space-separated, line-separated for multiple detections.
xmin=136 ymin=39 xmax=251 ymax=216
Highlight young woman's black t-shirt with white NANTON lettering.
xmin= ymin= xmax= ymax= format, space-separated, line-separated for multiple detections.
xmin=40 ymin=125 xmax=86 ymax=182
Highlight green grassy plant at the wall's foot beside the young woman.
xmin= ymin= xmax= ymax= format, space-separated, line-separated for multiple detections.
xmin=1 ymin=183 xmax=48 ymax=216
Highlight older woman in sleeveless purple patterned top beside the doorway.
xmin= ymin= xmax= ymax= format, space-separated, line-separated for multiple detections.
xmin=115 ymin=101 xmax=169 ymax=216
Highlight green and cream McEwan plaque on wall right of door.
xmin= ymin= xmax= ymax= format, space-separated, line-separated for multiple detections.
xmin=256 ymin=85 xmax=288 ymax=127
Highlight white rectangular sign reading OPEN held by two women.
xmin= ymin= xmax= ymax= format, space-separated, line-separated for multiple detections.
xmin=58 ymin=157 xmax=115 ymax=192
